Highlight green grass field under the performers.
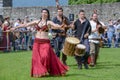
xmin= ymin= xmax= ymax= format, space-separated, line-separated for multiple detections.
xmin=0 ymin=48 xmax=120 ymax=80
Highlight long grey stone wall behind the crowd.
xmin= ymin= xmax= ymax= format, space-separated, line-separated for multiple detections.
xmin=3 ymin=3 xmax=120 ymax=22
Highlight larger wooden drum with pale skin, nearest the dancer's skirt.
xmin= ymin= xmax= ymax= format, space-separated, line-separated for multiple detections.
xmin=62 ymin=37 xmax=80 ymax=56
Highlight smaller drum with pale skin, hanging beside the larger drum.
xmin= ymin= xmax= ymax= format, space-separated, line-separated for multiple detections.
xmin=75 ymin=44 xmax=86 ymax=56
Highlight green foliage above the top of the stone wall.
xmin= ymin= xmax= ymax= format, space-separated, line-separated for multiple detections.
xmin=68 ymin=0 xmax=120 ymax=5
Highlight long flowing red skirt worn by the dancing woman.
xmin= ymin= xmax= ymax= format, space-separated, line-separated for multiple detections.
xmin=31 ymin=38 xmax=68 ymax=77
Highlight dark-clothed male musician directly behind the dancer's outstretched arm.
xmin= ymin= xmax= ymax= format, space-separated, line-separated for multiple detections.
xmin=52 ymin=8 xmax=70 ymax=65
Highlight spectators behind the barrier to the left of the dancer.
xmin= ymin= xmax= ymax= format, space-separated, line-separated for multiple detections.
xmin=0 ymin=16 xmax=35 ymax=51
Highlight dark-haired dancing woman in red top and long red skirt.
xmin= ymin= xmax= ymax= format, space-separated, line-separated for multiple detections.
xmin=11 ymin=9 xmax=68 ymax=77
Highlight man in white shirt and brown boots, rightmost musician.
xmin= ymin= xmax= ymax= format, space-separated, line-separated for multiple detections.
xmin=89 ymin=13 xmax=105 ymax=66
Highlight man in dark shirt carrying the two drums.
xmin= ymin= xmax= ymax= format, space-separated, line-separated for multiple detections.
xmin=74 ymin=10 xmax=91 ymax=69
